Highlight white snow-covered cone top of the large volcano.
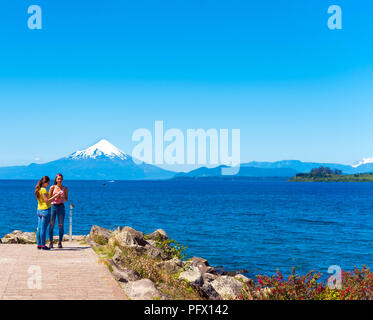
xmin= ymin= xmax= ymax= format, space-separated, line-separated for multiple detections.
xmin=68 ymin=139 xmax=128 ymax=160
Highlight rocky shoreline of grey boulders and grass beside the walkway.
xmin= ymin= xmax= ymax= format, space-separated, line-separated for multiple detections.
xmin=0 ymin=225 xmax=253 ymax=300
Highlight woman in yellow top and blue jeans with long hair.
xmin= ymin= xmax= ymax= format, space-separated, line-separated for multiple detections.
xmin=35 ymin=176 xmax=61 ymax=250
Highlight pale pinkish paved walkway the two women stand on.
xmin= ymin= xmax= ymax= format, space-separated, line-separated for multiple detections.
xmin=0 ymin=242 xmax=127 ymax=300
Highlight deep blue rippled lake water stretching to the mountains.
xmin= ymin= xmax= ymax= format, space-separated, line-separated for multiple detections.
xmin=0 ymin=180 xmax=373 ymax=276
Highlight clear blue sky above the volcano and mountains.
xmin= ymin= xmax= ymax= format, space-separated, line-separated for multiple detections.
xmin=0 ymin=0 xmax=373 ymax=166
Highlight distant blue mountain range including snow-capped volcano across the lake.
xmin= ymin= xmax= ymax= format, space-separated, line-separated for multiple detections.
xmin=0 ymin=139 xmax=373 ymax=180
